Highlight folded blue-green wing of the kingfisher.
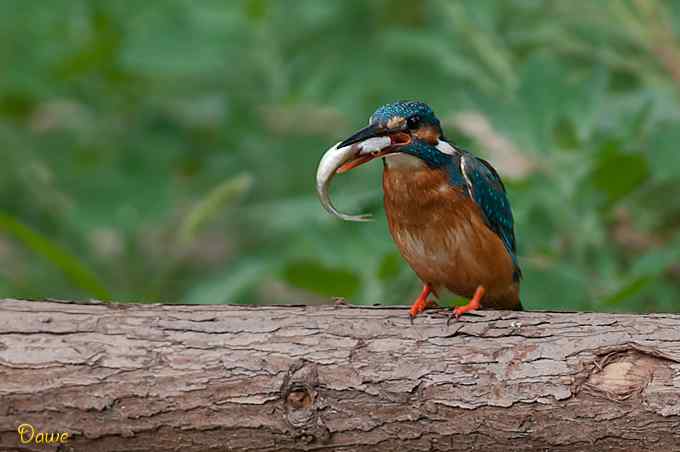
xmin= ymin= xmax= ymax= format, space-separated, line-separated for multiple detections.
xmin=461 ymin=152 xmax=522 ymax=280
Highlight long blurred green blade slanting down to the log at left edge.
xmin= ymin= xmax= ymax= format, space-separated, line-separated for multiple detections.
xmin=0 ymin=212 xmax=111 ymax=300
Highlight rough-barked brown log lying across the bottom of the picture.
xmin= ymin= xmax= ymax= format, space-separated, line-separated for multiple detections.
xmin=0 ymin=300 xmax=680 ymax=452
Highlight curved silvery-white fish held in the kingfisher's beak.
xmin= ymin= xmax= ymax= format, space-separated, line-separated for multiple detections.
xmin=316 ymin=137 xmax=390 ymax=221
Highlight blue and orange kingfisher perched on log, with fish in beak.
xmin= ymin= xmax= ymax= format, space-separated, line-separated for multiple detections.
xmin=317 ymin=101 xmax=522 ymax=320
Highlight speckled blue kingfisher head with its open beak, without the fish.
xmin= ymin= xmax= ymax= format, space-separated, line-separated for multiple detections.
xmin=337 ymin=101 xmax=451 ymax=173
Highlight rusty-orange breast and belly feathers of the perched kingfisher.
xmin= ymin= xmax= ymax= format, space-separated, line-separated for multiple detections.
xmin=383 ymin=167 xmax=519 ymax=308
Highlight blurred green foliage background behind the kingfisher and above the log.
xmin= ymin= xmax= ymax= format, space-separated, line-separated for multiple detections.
xmin=0 ymin=0 xmax=680 ymax=312
